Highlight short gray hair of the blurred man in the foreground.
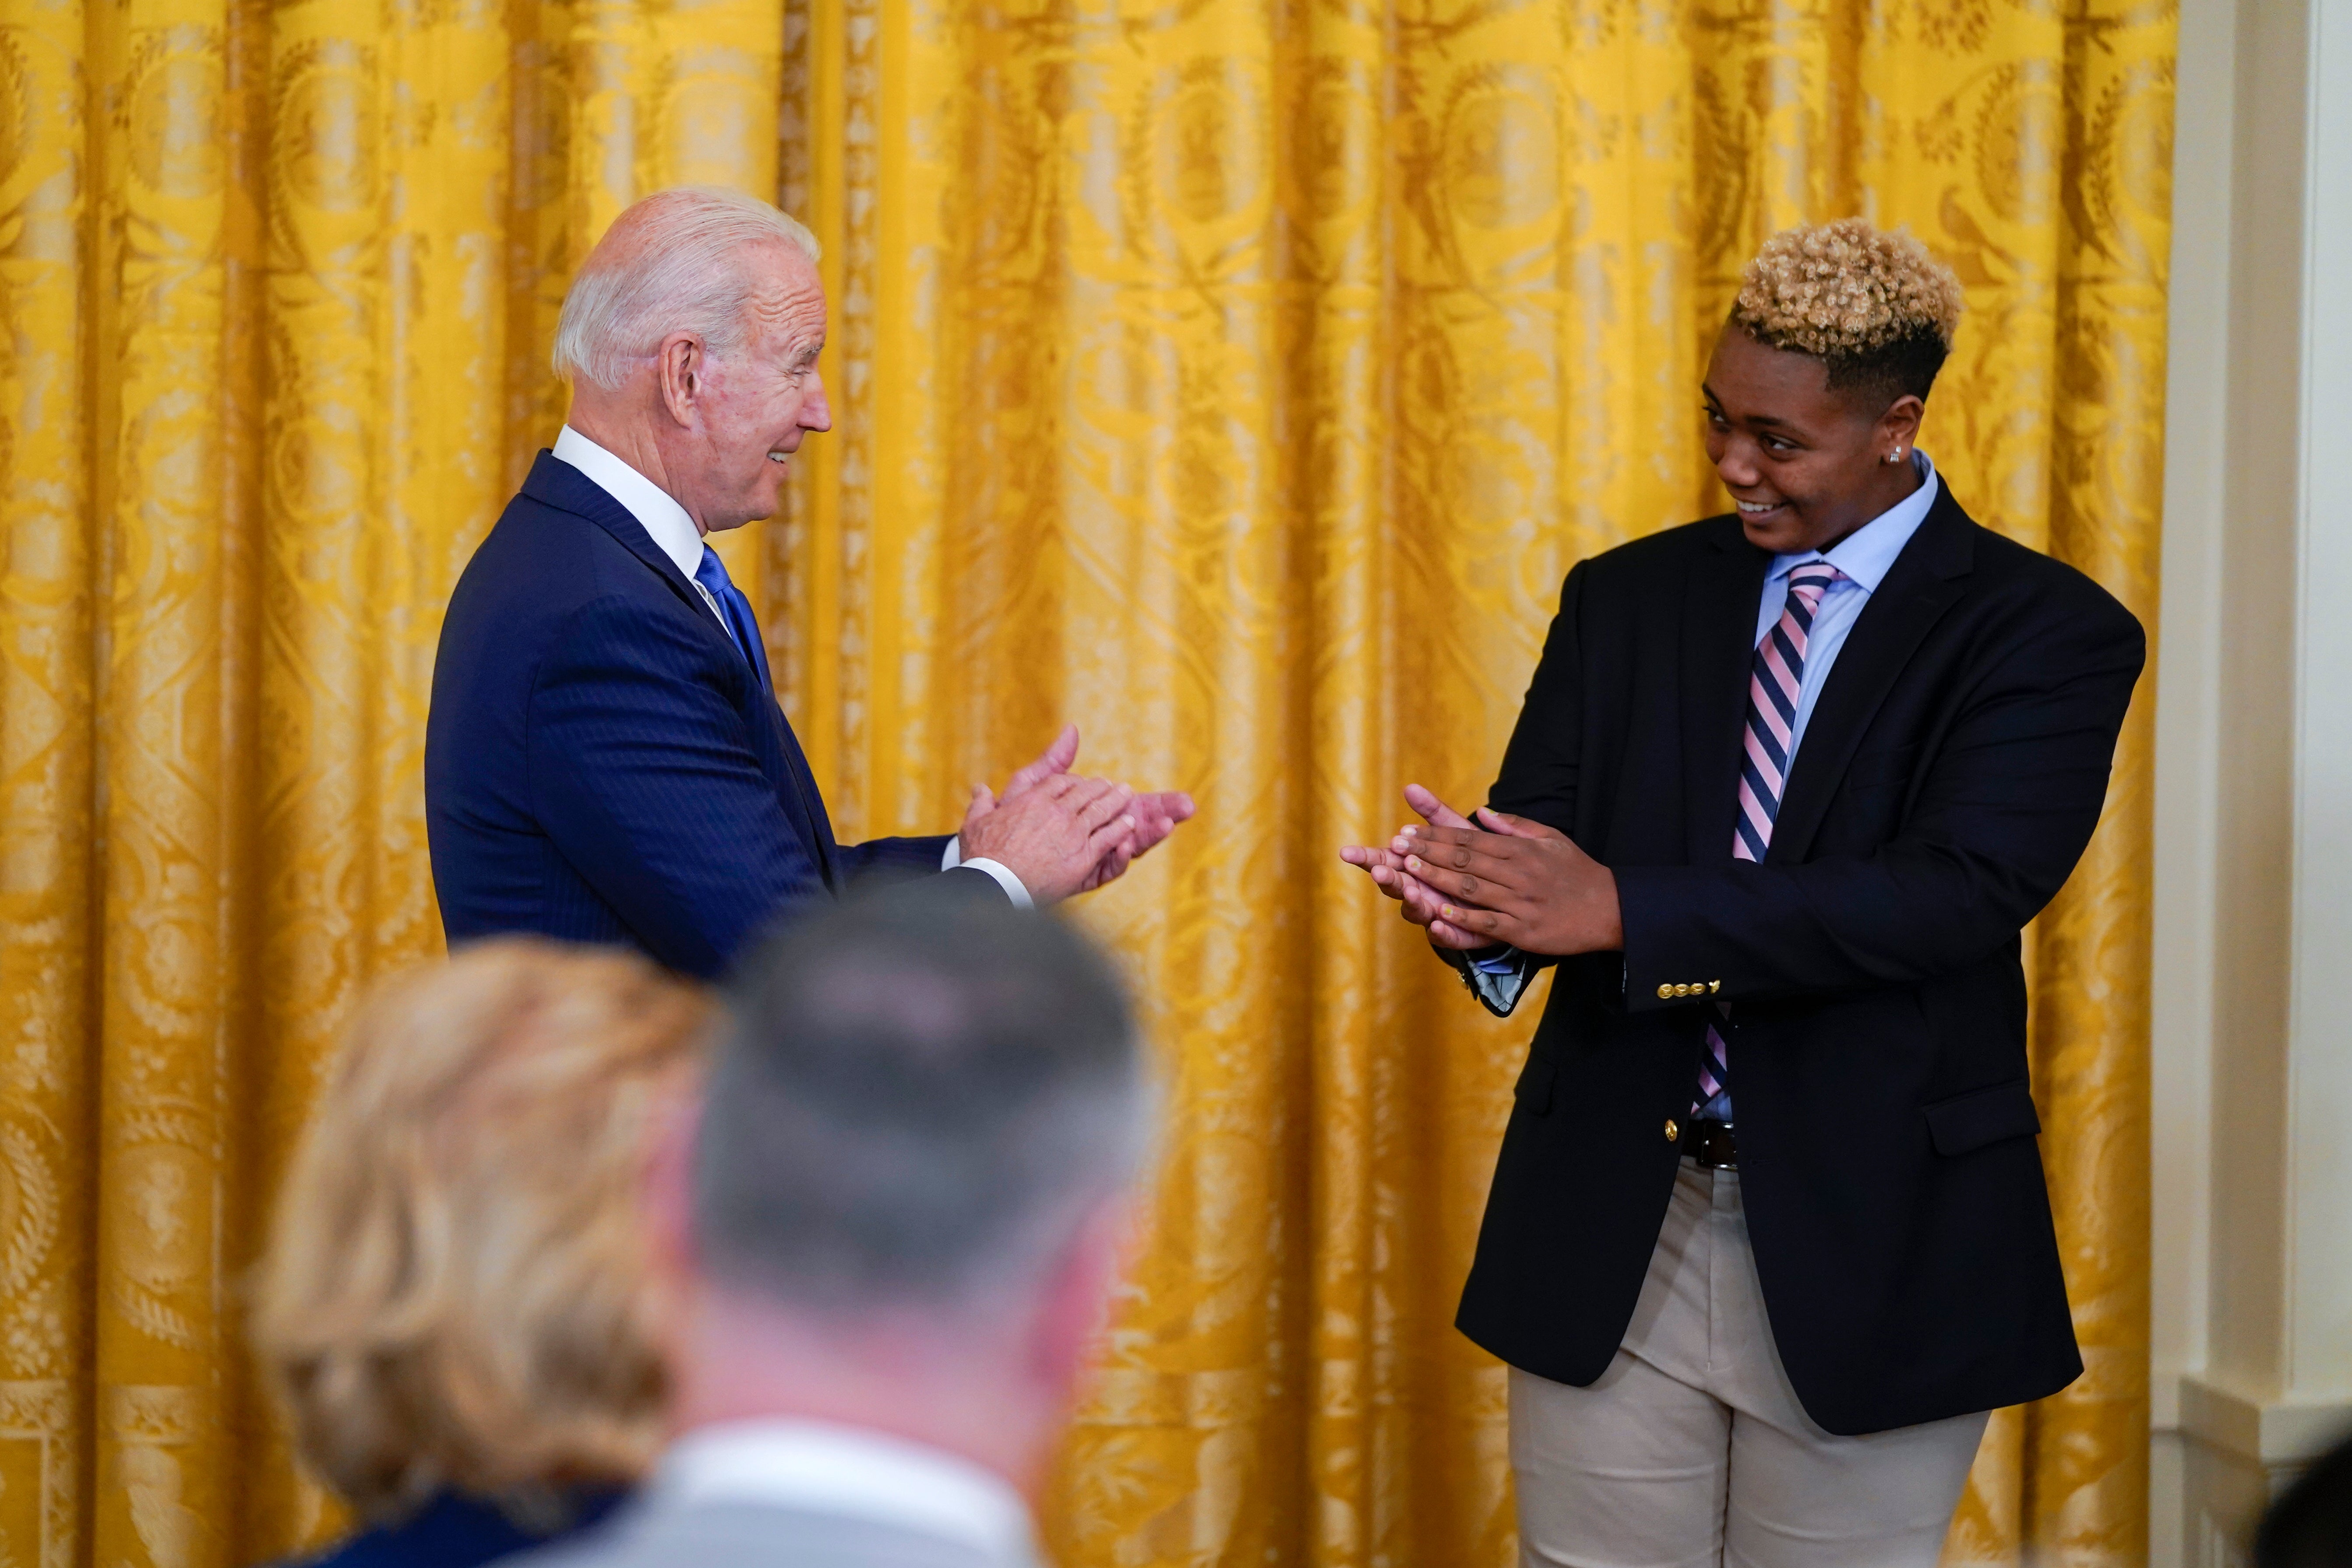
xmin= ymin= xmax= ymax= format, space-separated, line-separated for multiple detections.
xmin=694 ymin=884 xmax=1155 ymax=1324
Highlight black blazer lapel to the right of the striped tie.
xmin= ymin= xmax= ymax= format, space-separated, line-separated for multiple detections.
xmin=1764 ymin=489 xmax=1976 ymax=860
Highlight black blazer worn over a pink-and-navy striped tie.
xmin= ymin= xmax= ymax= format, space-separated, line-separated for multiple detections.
xmin=1456 ymin=489 xmax=2147 ymax=1436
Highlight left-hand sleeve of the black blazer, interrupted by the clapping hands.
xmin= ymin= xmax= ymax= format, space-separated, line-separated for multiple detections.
xmin=1437 ymin=562 xmax=1585 ymax=1018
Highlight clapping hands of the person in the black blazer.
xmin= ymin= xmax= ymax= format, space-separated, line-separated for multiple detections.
xmin=1338 ymin=785 xmax=1625 ymax=957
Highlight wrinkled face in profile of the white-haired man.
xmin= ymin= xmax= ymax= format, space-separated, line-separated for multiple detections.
xmin=689 ymin=244 xmax=832 ymax=531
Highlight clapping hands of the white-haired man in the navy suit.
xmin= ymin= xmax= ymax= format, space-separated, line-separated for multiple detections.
xmin=957 ymin=724 xmax=1192 ymax=905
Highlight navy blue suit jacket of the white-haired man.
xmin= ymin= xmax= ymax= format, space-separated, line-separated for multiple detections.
xmin=426 ymin=451 xmax=995 ymax=978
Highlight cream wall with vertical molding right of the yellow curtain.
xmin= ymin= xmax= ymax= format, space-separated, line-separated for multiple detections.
xmin=2150 ymin=0 xmax=2352 ymax=1568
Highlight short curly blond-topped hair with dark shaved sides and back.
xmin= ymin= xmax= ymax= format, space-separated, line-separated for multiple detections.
xmin=1731 ymin=218 xmax=1961 ymax=402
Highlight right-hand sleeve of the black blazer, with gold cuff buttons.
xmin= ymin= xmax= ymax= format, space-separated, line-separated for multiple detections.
xmin=1616 ymin=595 xmax=2145 ymax=1011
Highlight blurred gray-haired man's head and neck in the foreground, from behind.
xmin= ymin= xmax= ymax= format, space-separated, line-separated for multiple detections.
xmin=654 ymin=888 xmax=1150 ymax=1488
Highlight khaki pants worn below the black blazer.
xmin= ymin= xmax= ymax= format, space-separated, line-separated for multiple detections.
xmin=1510 ymin=1159 xmax=1985 ymax=1568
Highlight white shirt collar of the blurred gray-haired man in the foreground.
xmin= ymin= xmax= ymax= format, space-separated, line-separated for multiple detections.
xmin=652 ymin=1417 xmax=1035 ymax=1568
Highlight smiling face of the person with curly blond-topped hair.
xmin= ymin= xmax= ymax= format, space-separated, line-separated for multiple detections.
xmin=1703 ymin=324 xmax=1924 ymax=555
